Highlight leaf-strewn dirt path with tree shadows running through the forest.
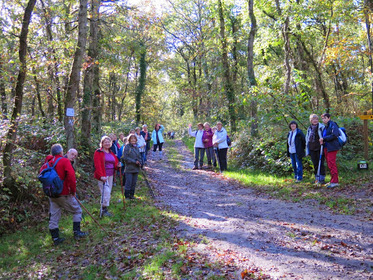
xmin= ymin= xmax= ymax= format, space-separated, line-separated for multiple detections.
xmin=146 ymin=140 xmax=373 ymax=280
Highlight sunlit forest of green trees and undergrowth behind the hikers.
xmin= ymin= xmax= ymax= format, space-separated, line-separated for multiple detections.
xmin=0 ymin=0 xmax=373 ymax=278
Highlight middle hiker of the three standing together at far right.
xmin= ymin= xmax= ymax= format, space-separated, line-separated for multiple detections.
xmin=306 ymin=114 xmax=325 ymax=184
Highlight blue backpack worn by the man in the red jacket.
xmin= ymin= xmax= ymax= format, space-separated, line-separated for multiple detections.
xmin=38 ymin=157 xmax=63 ymax=197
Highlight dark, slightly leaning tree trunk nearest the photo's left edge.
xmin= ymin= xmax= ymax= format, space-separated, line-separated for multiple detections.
xmin=3 ymin=0 xmax=36 ymax=198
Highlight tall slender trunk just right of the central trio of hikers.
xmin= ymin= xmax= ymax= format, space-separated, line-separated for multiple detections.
xmin=247 ymin=0 xmax=258 ymax=137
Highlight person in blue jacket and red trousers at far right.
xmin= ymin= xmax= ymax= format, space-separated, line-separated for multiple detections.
xmin=320 ymin=113 xmax=341 ymax=188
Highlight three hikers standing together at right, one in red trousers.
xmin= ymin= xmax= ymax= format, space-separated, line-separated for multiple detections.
xmin=287 ymin=113 xmax=341 ymax=188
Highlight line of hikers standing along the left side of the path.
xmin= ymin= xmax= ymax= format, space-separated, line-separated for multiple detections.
xmin=40 ymin=123 xmax=164 ymax=245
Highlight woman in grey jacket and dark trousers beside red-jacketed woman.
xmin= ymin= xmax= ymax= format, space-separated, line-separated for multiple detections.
xmin=122 ymin=135 xmax=141 ymax=199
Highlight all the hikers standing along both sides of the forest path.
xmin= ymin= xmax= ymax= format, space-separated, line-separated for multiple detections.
xmin=40 ymin=113 xmax=341 ymax=245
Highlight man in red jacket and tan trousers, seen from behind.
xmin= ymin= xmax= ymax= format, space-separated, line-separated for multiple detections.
xmin=40 ymin=144 xmax=88 ymax=245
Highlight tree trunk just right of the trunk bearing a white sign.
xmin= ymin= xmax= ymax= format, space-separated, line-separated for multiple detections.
xmin=81 ymin=0 xmax=101 ymax=150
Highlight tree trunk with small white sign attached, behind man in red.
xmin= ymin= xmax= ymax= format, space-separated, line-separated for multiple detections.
xmin=65 ymin=0 xmax=88 ymax=149
